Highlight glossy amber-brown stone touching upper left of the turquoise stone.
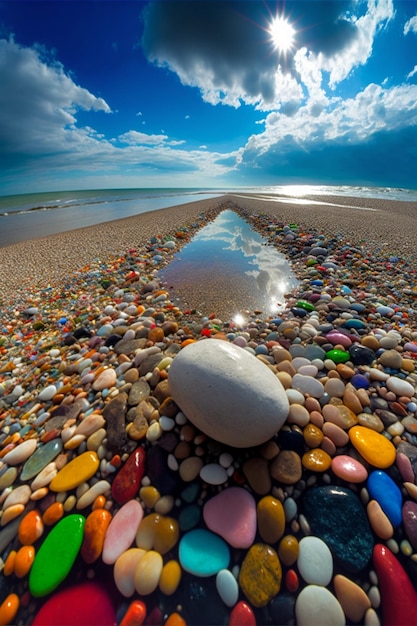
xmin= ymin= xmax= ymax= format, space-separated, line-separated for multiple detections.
xmin=136 ymin=513 xmax=179 ymax=555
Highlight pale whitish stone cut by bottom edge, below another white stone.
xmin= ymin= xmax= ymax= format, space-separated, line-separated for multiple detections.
xmin=295 ymin=585 xmax=346 ymax=626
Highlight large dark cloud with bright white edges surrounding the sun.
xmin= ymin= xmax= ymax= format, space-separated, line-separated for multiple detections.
xmin=142 ymin=0 xmax=394 ymax=111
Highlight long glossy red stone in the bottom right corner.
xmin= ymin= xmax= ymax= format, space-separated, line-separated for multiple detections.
xmin=373 ymin=543 xmax=417 ymax=626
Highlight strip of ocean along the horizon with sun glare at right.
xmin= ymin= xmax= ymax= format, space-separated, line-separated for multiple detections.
xmin=0 ymin=185 xmax=417 ymax=247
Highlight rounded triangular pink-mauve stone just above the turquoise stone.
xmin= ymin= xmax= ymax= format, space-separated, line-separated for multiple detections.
xmin=203 ymin=487 xmax=256 ymax=548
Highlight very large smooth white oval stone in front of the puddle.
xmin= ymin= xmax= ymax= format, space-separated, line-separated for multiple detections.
xmin=168 ymin=339 xmax=289 ymax=448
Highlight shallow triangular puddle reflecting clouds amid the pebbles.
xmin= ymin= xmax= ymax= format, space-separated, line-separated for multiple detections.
xmin=158 ymin=210 xmax=298 ymax=323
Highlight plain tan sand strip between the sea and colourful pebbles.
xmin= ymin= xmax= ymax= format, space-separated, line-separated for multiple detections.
xmin=0 ymin=193 xmax=417 ymax=306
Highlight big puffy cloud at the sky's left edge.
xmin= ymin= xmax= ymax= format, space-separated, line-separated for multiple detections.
xmin=0 ymin=38 xmax=110 ymax=166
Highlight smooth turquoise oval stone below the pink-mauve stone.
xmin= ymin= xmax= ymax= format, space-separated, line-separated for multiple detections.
xmin=179 ymin=528 xmax=230 ymax=577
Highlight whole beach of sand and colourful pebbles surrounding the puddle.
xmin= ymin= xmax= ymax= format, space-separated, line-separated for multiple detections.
xmin=0 ymin=193 xmax=417 ymax=626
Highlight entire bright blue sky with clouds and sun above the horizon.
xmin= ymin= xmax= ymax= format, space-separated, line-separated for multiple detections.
xmin=0 ymin=0 xmax=417 ymax=195
